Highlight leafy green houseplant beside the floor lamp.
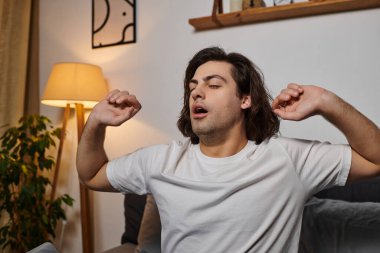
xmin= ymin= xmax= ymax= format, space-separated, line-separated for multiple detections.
xmin=0 ymin=115 xmax=73 ymax=252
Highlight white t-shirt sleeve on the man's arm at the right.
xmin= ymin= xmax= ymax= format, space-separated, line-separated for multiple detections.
xmin=278 ymin=137 xmax=351 ymax=194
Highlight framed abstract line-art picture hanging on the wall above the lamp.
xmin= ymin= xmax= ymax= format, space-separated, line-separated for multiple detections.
xmin=92 ymin=0 xmax=136 ymax=48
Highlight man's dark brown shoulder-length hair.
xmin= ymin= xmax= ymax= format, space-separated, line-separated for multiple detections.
xmin=177 ymin=47 xmax=280 ymax=144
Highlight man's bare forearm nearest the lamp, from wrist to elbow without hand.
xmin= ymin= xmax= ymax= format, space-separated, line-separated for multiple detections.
xmin=76 ymin=116 xmax=108 ymax=183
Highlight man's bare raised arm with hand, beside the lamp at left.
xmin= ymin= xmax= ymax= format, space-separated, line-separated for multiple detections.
xmin=76 ymin=90 xmax=141 ymax=191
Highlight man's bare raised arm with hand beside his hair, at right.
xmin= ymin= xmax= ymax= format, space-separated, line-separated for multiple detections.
xmin=272 ymin=84 xmax=380 ymax=181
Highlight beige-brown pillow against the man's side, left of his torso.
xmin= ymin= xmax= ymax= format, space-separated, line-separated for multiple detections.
xmin=135 ymin=195 xmax=161 ymax=253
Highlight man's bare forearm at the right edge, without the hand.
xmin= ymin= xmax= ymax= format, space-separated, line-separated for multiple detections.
xmin=321 ymin=92 xmax=380 ymax=164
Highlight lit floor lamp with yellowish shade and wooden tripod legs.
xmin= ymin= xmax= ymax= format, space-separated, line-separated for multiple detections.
xmin=41 ymin=62 xmax=107 ymax=253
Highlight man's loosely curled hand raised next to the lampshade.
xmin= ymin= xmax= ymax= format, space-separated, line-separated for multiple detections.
xmin=90 ymin=90 xmax=141 ymax=126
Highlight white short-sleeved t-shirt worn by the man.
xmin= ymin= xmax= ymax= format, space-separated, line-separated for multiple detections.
xmin=107 ymin=137 xmax=351 ymax=253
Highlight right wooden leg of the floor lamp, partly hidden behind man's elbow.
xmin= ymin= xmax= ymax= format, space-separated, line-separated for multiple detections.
xmin=75 ymin=103 xmax=94 ymax=253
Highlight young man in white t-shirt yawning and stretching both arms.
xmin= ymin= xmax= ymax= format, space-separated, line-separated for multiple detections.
xmin=77 ymin=48 xmax=380 ymax=253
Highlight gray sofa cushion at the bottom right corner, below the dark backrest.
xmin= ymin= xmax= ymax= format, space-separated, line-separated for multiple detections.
xmin=299 ymin=198 xmax=380 ymax=253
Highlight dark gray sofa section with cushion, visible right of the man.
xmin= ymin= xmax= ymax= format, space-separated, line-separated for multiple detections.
xmin=299 ymin=178 xmax=380 ymax=253
